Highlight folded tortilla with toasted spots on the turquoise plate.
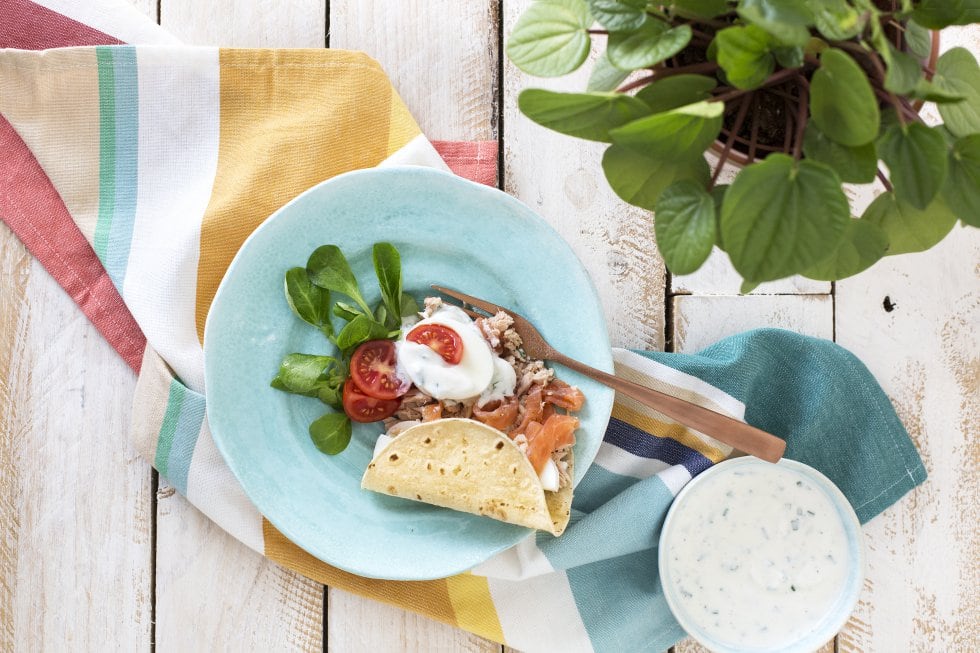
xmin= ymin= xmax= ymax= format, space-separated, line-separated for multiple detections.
xmin=361 ymin=418 xmax=572 ymax=536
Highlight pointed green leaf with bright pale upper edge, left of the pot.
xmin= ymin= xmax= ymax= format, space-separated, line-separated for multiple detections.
xmin=609 ymin=102 xmax=725 ymax=161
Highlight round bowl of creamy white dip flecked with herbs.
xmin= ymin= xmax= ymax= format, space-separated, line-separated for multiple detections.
xmin=659 ymin=456 xmax=864 ymax=653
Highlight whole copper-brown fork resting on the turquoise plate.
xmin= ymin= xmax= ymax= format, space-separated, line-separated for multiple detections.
xmin=432 ymin=285 xmax=786 ymax=463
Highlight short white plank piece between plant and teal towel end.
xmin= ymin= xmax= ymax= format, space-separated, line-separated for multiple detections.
xmin=673 ymin=295 xmax=833 ymax=352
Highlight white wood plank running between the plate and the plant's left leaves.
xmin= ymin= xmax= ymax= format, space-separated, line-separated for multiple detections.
xmin=503 ymin=0 xmax=666 ymax=349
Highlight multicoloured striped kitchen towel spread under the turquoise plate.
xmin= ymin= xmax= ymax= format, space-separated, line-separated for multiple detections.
xmin=0 ymin=0 xmax=925 ymax=651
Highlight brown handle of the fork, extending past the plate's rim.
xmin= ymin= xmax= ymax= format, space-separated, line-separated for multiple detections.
xmin=549 ymin=351 xmax=786 ymax=463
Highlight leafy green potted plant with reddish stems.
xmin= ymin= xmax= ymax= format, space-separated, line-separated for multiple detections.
xmin=506 ymin=0 xmax=980 ymax=292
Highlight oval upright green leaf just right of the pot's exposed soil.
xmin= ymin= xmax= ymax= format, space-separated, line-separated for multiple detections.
xmin=810 ymin=48 xmax=881 ymax=147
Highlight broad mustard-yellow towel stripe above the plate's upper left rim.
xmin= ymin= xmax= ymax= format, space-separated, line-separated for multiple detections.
xmin=195 ymin=49 xmax=421 ymax=342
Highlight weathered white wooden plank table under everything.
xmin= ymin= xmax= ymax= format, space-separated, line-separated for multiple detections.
xmin=0 ymin=0 xmax=980 ymax=653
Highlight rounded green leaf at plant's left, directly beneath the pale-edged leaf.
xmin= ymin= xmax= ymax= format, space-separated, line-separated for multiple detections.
xmin=602 ymin=145 xmax=711 ymax=211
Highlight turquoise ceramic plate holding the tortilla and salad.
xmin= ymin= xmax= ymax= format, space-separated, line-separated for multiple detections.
xmin=204 ymin=167 xmax=613 ymax=580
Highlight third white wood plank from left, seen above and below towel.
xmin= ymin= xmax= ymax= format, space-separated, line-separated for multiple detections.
xmin=327 ymin=0 xmax=499 ymax=651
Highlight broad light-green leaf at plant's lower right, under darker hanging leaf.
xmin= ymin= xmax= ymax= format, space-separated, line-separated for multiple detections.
xmin=861 ymin=192 xmax=956 ymax=256
